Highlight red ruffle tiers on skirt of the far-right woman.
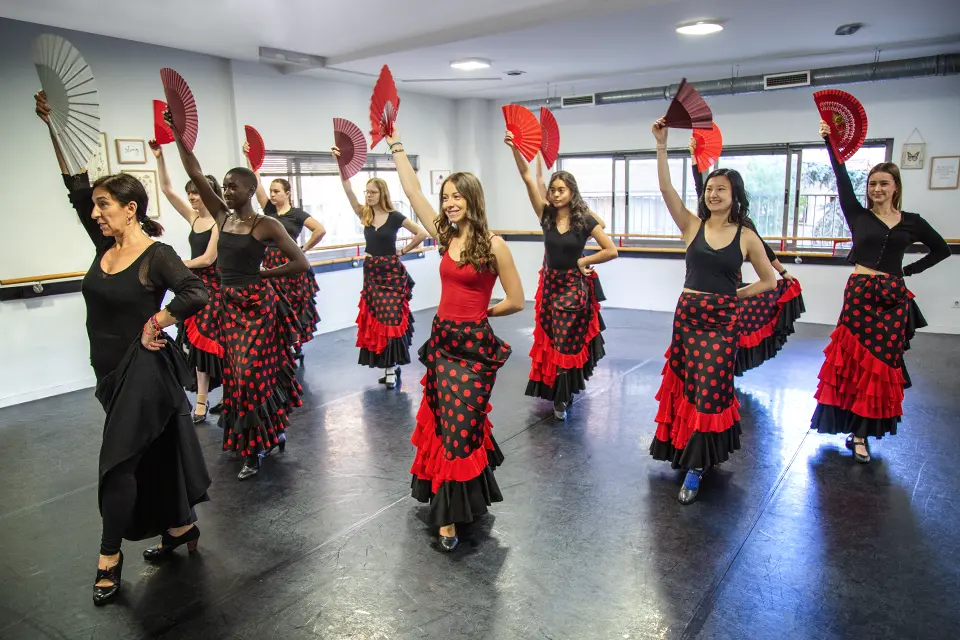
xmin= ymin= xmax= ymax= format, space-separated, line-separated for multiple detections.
xmin=814 ymin=325 xmax=906 ymax=419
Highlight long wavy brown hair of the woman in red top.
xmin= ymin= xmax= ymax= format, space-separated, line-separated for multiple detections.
xmin=435 ymin=171 xmax=497 ymax=273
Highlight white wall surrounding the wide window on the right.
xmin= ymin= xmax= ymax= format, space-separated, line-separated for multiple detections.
xmin=488 ymin=76 xmax=960 ymax=333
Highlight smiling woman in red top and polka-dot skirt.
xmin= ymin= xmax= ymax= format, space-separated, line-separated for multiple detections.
xmin=387 ymin=131 xmax=523 ymax=551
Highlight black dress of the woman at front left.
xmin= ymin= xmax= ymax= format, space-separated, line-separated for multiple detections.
xmin=64 ymin=173 xmax=210 ymax=540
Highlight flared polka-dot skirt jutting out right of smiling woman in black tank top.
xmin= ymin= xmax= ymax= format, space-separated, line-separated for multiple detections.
xmin=734 ymin=280 xmax=806 ymax=376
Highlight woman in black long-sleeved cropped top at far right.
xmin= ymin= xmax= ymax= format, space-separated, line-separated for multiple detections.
xmin=810 ymin=120 xmax=950 ymax=464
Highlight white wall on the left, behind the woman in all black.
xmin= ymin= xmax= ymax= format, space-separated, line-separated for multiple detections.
xmin=0 ymin=19 xmax=457 ymax=406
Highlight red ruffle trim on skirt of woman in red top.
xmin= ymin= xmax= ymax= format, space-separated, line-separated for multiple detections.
xmin=410 ymin=376 xmax=493 ymax=493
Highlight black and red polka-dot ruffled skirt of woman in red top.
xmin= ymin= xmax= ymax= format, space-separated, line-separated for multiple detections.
xmin=410 ymin=317 xmax=511 ymax=526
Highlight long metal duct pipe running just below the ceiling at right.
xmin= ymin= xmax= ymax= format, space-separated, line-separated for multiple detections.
xmin=516 ymin=53 xmax=960 ymax=109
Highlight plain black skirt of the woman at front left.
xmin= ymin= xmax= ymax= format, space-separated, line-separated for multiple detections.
xmin=96 ymin=337 xmax=210 ymax=540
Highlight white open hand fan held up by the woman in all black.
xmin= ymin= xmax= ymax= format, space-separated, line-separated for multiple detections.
xmin=33 ymin=33 xmax=100 ymax=174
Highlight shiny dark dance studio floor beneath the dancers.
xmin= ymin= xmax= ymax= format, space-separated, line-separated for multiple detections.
xmin=0 ymin=305 xmax=960 ymax=640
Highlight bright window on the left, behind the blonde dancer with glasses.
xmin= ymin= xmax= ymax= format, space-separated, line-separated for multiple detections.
xmin=260 ymin=151 xmax=419 ymax=249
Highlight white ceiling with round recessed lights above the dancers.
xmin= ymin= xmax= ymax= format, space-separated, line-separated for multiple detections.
xmin=0 ymin=0 xmax=960 ymax=99
